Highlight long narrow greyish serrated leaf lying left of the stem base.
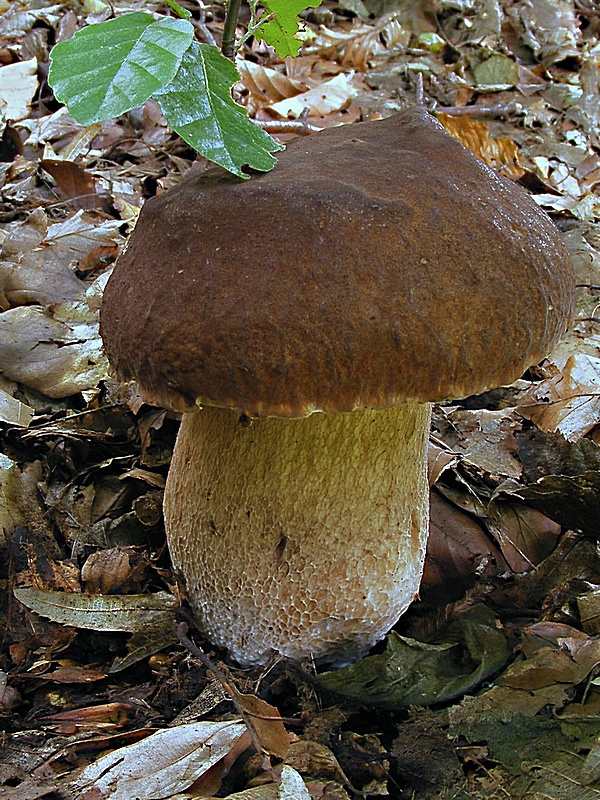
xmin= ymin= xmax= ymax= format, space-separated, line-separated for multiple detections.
xmin=14 ymin=586 xmax=178 ymax=633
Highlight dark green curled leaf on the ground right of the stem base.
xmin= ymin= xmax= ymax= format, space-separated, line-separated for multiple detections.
xmin=317 ymin=605 xmax=511 ymax=709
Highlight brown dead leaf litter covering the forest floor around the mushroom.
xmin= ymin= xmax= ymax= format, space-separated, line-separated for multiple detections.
xmin=0 ymin=0 xmax=600 ymax=800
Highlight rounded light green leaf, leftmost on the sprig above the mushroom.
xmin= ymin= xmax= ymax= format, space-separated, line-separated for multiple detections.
xmin=48 ymin=11 xmax=194 ymax=125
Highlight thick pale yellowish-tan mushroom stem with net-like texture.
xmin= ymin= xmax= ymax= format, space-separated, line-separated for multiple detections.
xmin=165 ymin=403 xmax=431 ymax=664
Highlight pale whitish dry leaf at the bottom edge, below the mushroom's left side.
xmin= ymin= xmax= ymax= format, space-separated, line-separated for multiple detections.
xmin=75 ymin=722 xmax=246 ymax=800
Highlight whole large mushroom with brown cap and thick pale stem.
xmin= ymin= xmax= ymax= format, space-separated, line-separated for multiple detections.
xmin=101 ymin=109 xmax=574 ymax=665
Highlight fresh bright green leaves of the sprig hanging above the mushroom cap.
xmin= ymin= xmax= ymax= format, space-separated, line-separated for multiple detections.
xmin=48 ymin=0 xmax=320 ymax=177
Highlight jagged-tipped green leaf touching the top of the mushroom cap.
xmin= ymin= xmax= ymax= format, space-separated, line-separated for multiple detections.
xmin=154 ymin=42 xmax=283 ymax=178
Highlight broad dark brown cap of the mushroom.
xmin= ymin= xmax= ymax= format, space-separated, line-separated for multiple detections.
xmin=101 ymin=109 xmax=573 ymax=417
